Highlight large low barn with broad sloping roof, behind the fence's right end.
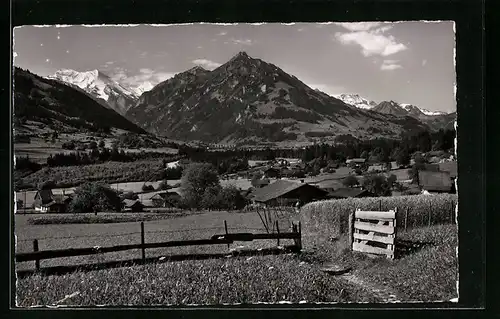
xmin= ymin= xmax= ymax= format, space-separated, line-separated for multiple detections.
xmin=252 ymin=180 xmax=328 ymax=206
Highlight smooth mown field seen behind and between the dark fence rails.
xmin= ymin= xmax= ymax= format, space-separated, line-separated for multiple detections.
xmin=15 ymin=211 xmax=293 ymax=270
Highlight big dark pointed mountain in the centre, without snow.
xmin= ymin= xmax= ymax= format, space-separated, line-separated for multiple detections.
xmin=126 ymin=52 xmax=434 ymax=143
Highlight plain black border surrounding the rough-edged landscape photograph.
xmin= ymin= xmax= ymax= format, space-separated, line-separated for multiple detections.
xmin=0 ymin=0 xmax=488 ymax=317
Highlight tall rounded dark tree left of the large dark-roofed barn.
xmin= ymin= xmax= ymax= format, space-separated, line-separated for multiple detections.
xmin=181 ymin=163 xmax=219 ymax=208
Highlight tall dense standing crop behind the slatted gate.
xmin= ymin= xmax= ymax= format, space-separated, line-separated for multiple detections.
xmin=301 ymin=194 xmax=458 ymax=241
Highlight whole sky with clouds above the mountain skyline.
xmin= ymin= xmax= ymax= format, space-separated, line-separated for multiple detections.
xmin=13 ymin=21 xmax=456 ymax=112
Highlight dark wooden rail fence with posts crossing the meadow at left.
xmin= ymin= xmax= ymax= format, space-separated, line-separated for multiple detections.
xmin=15 ymin=221 xmax=302 ymax=270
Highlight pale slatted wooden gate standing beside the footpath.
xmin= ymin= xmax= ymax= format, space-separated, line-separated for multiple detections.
xmin=349 ymin=209 xmax=397 ymax=259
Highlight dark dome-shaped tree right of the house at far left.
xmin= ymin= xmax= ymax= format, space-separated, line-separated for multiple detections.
xmin=70 ymin=183 xmax=122 ymax=213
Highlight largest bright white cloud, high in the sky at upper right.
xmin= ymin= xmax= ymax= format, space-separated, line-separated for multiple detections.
xmin=335 ymin=22 xmax=408 ymax=57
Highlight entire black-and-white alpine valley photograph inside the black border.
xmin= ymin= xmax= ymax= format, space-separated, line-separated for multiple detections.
xmin=12 ymin=22 xmax=459 ymax=307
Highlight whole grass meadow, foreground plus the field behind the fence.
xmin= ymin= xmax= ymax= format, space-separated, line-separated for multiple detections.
xmin=16 ymin=196 xmax=458 ymax=307
